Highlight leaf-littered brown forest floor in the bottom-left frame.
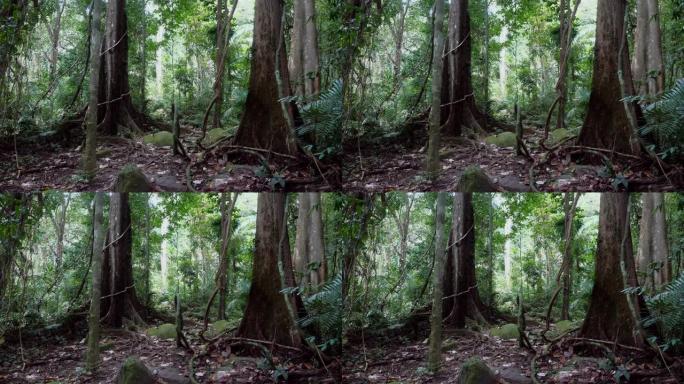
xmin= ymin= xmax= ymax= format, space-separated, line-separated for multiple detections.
xmin=0 ymin=316 xmax=340 ymax=384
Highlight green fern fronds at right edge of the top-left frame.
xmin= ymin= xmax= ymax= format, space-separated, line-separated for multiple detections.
xmin=285 ymin=80 xmax=344 ymax=158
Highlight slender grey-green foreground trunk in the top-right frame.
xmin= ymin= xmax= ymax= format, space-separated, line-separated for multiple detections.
xmin=426 ymin=0 xmax=448 ymax=181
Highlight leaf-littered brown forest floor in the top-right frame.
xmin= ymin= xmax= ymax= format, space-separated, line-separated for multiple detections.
xmin=343 ymin=128 xmax=684 ymax=192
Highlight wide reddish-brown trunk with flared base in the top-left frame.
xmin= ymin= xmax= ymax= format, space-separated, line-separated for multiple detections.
xmin=235 ymin=0 xmax=298 ymax=154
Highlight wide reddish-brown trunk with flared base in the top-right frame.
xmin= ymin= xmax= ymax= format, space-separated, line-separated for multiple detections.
xmin=578 ymin=0 xmax=641 ymax=155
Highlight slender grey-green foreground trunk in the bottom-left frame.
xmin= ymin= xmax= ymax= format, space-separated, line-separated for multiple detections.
xmin=86 ymin=192 xmax=105 ymax=372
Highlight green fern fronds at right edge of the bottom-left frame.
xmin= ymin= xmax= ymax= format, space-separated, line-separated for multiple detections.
xmin=298 ymin=274 xmax=342 ymax=344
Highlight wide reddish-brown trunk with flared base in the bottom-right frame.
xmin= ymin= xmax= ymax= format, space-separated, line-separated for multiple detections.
xmin=580 ymin=193 xmax=644 ymax=346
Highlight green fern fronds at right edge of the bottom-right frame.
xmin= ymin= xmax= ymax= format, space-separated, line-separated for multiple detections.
xmin=644 ymin=274 xmax=684 ymax=352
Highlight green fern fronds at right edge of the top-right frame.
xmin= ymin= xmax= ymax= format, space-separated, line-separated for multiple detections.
xmin=640 ymin=79 xmax=684 ymax=158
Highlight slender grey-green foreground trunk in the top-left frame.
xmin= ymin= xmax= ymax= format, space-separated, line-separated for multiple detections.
xmin=83 ymin=0 xmax=102 ymax=180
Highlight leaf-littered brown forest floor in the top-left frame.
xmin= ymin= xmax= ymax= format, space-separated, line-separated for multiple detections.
xmin=0 ymin=127 xmax=339 ymax=192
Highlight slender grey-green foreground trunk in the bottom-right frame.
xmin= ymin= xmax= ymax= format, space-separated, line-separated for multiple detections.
xmin=428 ymin=192 xmax=447 ymax=372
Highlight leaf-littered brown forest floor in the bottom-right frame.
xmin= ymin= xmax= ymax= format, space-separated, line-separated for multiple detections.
xmin=342 ymin=325 xmax=684 ymax=384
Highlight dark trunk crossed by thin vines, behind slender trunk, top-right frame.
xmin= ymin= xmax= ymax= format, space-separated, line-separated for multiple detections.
xmin=441 ymin=0 xmax=482 ymax=136
